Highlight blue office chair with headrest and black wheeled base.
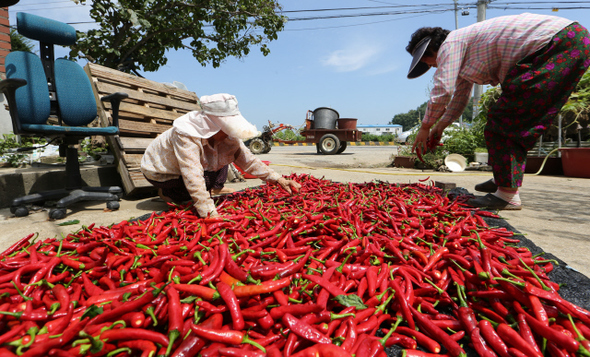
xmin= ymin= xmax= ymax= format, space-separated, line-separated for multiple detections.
xmin=0 ymin=12 xmax=127 ymax=219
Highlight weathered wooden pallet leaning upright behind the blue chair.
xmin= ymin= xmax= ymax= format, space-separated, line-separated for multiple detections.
xmin=84 ymin=63 xmax=200 ymax=195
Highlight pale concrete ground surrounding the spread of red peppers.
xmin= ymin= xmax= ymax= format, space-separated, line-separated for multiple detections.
xmin=0 ymin=147 xmax=590 ymax=276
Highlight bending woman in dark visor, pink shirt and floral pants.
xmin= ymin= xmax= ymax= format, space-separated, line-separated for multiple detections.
xmin=406 ymin=13 xmax=590 ymax=210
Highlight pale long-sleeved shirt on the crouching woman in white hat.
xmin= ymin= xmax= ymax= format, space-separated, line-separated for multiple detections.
xmin=141 ymin=127 xmax=281 ymax=217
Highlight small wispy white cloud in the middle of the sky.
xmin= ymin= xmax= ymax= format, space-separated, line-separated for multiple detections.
xmin=321 ymin=42 xmax=382 ymax=72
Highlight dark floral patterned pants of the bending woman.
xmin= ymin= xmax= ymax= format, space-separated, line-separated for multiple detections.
xmin=484 ymin=23 xmax=590 ymax=188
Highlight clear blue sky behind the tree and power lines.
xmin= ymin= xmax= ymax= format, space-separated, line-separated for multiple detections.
xmin=9 ymin=0 xmax=590 ymax=130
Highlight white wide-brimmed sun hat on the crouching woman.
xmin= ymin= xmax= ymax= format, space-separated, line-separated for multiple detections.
xmin=173 ymin=93 xmax=260 ymax=140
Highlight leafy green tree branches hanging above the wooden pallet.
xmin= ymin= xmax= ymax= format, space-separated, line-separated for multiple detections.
xmin=70 ymin=0 xmax=286 ymax=73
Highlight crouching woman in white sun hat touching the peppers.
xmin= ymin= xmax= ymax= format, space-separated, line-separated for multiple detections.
xmin=141 ymin=94 xmax=301 ymax=217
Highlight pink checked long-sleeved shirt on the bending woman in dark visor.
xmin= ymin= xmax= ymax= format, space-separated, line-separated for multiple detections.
xmin=422 ymin=13 xmax=573 ymax=126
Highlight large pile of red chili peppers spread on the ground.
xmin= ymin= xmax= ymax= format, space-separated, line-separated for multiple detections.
xmin=0 ymin=174 xmax=590 ymax=357
